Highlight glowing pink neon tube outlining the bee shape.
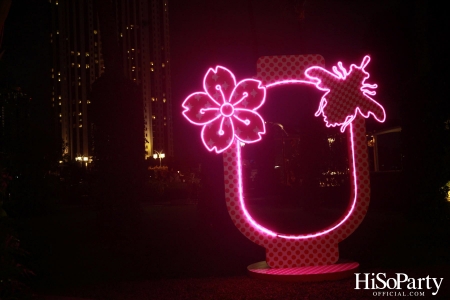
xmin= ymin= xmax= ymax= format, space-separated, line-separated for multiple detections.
xmin=305 ymin=55 xmax=386 ymax=132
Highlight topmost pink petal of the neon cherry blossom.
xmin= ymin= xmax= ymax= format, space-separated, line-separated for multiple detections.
xmin=203 ymin=66 xmax=236 ymax=105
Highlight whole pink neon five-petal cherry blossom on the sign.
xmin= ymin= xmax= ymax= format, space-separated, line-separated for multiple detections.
xmin=182 ymin=66 xmax=266 ymax=153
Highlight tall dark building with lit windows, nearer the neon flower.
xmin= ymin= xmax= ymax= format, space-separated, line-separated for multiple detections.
xmin=116 ymin=0 xmax=173 ymax=159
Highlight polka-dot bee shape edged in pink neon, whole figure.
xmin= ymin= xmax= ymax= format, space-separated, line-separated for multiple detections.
xmin=305 ymin=56 xmax=386 ymax=132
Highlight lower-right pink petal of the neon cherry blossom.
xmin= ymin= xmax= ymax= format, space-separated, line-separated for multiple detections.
xmin=233 ymin=109 xmax=266 ymax=143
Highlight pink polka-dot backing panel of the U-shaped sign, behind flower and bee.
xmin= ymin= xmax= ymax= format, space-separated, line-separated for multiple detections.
xmin=223 ymin=59 xmax=370 ymax=268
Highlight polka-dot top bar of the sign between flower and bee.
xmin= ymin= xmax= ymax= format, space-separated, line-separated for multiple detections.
xmin=256 ymin=54 xmax=325 ymax=85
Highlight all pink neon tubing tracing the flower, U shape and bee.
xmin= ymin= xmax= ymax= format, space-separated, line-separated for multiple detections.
xmin=183 ymin=55 xmax=386 ymax=240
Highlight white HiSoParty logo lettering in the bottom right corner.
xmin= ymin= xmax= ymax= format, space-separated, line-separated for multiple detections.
xmin=355 ymin=273 xmax=444 ymax=296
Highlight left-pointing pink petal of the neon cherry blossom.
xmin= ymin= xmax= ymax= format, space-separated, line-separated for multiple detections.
xmin=182 ymin=93 xmax=220 ymax=125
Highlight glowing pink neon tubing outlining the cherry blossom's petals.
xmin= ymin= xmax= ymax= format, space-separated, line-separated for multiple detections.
xmin=182 ymin=66 xmax=266 ymax=153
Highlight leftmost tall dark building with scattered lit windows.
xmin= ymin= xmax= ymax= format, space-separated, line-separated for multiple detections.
xmin=50 ymin=0 xmax=104 ymax=160
